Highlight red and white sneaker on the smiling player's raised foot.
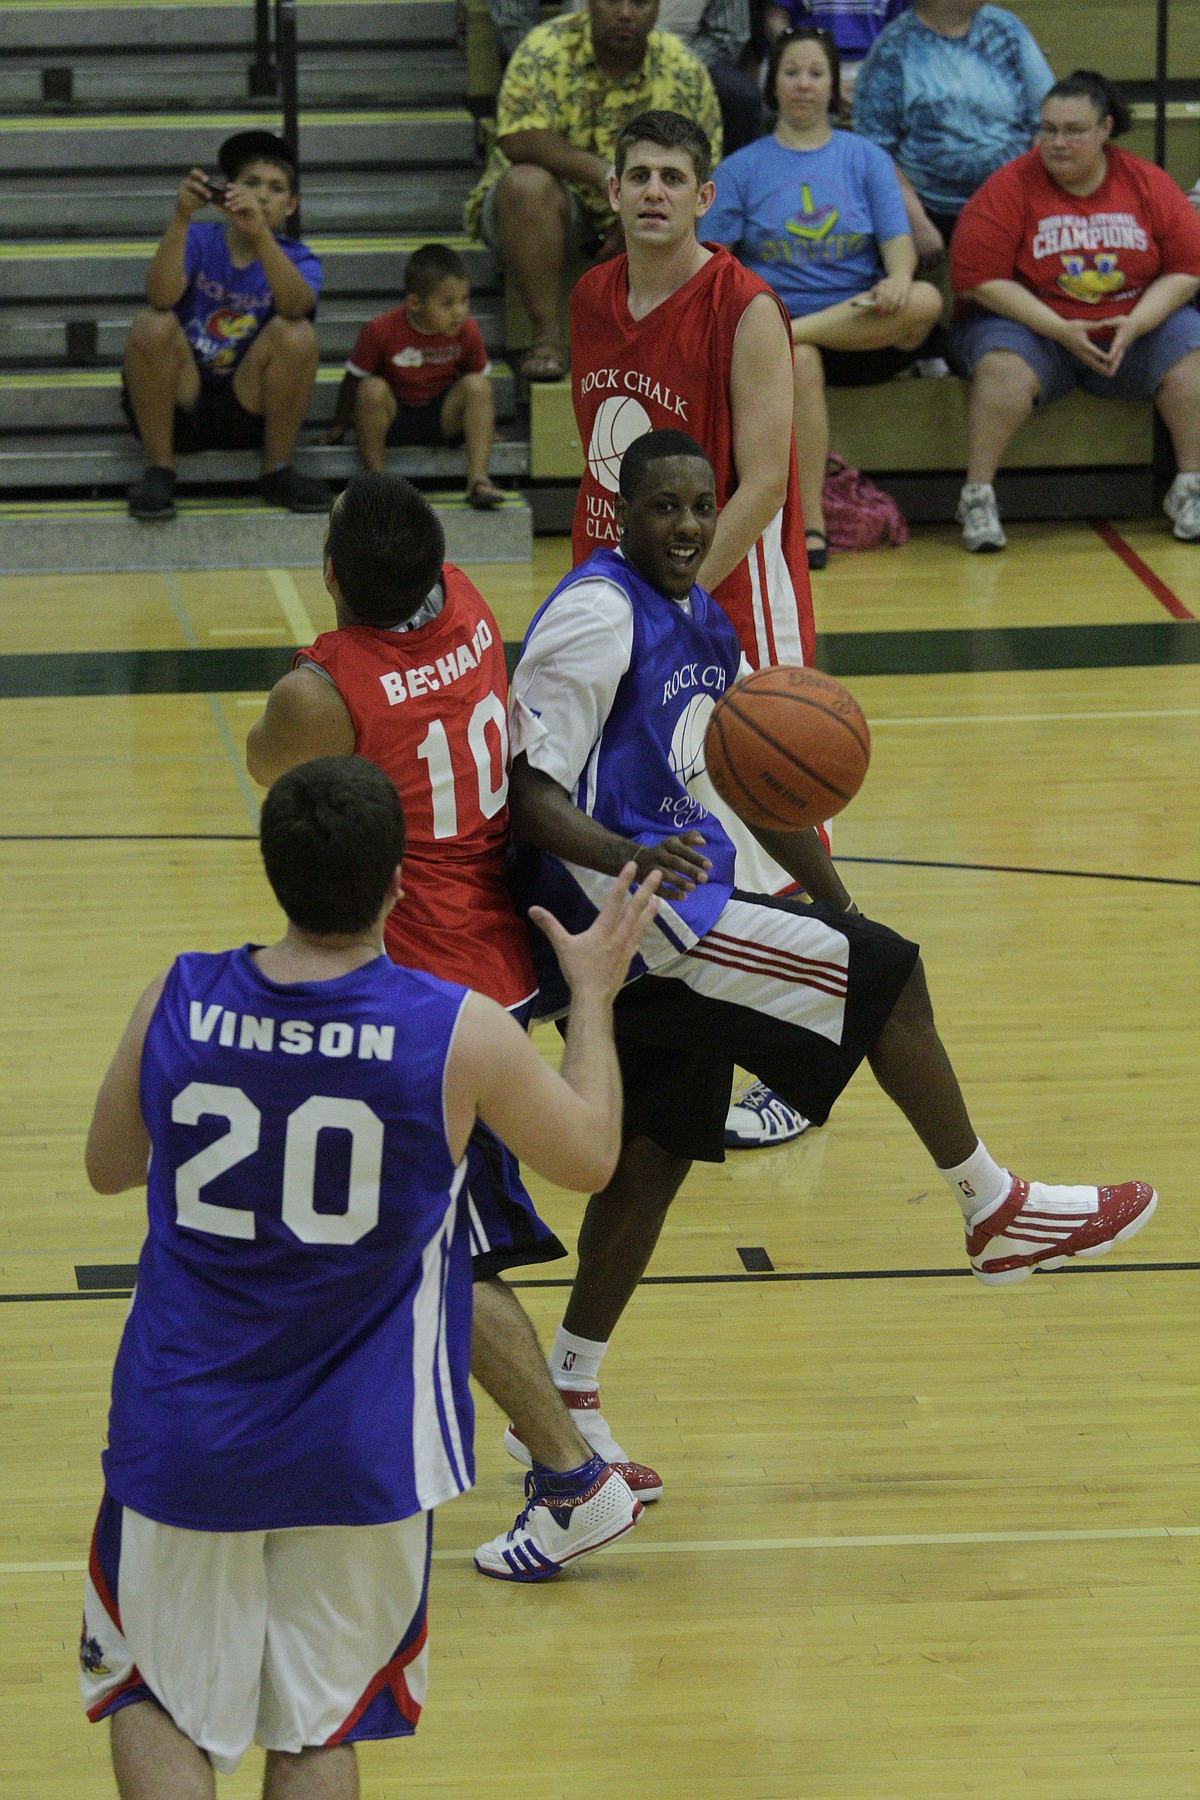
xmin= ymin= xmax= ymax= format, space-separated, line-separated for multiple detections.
xmin=966 ymin=1175 xmax=1159 ymax=1287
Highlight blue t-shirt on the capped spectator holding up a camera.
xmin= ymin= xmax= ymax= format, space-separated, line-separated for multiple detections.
xmin=175 ymin=220 xmax=320 ymax=382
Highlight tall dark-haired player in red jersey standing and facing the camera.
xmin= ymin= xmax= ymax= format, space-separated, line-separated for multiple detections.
xmin=570 ymin=112 xmax=813 ymax=668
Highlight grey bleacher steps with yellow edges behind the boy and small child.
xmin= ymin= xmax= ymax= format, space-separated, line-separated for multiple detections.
xmin=0 ymin=0 xmax=531 ymax=569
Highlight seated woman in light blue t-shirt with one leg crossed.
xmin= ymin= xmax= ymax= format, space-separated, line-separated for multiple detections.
xmin=703 ymin=25 xmax=941 ymax=569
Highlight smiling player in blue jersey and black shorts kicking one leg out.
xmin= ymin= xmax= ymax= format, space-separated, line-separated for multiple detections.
xmin=506 ymin=430 xmax=1157 ymax=1483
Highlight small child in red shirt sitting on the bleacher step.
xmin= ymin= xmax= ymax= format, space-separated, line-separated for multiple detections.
xmin=327 ymin=243 xmax=504 ymax=509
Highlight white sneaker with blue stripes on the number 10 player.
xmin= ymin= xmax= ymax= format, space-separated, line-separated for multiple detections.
xmin=475 ymin=1456 xmax=644 ymax=1580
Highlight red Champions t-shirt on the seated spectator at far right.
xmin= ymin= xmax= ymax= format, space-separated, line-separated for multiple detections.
xmin=950 ymin=144 xmax=1200 ymax=320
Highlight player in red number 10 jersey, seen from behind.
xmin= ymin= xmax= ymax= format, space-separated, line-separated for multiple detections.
xmin=246 ymin=473 xmax=658 ymax=1580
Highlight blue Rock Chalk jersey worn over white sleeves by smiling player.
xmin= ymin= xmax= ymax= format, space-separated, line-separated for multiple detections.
xmin=513 ymin=549 xmax=741 ymax=1013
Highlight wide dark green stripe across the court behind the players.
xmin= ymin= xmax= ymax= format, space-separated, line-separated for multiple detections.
xmin=0 ymin=621 xmax=1200 ymax=700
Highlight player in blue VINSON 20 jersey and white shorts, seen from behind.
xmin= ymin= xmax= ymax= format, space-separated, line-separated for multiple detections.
xmin=79 ymin=758 xmax=655 ymax=1800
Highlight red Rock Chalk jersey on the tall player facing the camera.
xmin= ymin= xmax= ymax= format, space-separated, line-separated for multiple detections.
xmin=570 ymin=245 xmax=815 ymax=668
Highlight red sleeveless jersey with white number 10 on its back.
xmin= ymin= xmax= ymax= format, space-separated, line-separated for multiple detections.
xmin=293 ymin=563 xmax=538 ymax=1006
